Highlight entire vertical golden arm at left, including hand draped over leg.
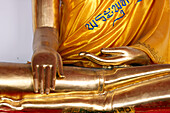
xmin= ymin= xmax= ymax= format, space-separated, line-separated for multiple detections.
xmin=32 ymin=0 xmax=63 ymax=94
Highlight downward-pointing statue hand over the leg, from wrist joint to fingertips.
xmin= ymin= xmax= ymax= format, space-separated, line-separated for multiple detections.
xmin=32 ymin=47 xmax=63 ymax=94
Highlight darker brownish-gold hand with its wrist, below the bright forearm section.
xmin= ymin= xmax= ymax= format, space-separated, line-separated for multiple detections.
xmin=32 ymin=27 xmax=63 ymax=94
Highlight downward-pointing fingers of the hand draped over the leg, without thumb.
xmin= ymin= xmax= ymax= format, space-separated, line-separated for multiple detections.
xmin=33 ymin=65 xmax=55 ymax=94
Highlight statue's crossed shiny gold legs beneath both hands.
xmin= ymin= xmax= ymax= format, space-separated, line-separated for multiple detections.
xmin=0 ymin=63 xmax=170 ymax=111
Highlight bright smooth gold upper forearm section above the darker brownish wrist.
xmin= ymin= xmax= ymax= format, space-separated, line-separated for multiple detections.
xmin=32 ymin=0 xmax=59 ymax=31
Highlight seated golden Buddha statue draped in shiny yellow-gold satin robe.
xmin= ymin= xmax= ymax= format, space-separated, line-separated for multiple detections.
xmin=0 ymin=0 xmax=170 ymax=111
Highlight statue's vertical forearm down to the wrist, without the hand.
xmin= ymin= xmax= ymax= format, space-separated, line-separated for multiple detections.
xmin=32 ymin=0 xmax=59 ymax=51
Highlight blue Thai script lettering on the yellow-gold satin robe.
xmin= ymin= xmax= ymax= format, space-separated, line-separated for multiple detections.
xmin=85 ymin=0 xmax=142 ymax=30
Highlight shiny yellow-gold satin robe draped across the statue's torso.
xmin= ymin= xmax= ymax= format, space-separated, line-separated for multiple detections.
xmin=58 ymin=0 xmax=170 ymax=67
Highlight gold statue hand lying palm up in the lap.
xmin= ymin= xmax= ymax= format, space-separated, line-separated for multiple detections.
xmin=79 ymin=46 xmax=150 ymax=66
